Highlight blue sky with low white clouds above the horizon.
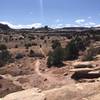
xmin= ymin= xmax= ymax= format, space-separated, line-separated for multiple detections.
xmin=0 ymin=0 xmax=100 ymax=28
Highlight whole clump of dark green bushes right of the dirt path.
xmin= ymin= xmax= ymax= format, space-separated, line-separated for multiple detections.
xmin=47 ymin=37 xmax=85 ymax=67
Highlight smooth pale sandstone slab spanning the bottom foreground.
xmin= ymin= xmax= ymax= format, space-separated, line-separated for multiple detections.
xmin=1 ymin=82 xmax=100 ymax=100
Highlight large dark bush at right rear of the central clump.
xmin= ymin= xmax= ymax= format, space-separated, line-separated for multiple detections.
xmin=64 ymin=37 xmax=85 ymax=60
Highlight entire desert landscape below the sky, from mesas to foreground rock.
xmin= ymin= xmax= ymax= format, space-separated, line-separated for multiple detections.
xmin=0 ymin=24 xmax=100 ymax=100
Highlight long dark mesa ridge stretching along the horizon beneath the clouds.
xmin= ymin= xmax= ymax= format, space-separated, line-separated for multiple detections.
xmin=0 ymin=23 xmax=100 ymax=33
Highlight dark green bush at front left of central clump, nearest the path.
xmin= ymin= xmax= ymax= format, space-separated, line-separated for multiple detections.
xmin=47 ymin=47 xmax=63 ymax=67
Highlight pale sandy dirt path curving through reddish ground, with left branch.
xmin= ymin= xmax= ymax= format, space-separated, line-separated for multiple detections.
xmin=0 ymin=59 xmax=72 ymax=89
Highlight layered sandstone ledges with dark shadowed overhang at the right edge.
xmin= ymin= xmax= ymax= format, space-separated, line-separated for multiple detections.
xmin=71 ymin=62 xmax=100 ymax=80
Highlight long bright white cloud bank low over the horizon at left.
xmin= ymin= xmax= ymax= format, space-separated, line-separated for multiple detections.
xmin=0 ymin=21 xmax=42 ymax=29
